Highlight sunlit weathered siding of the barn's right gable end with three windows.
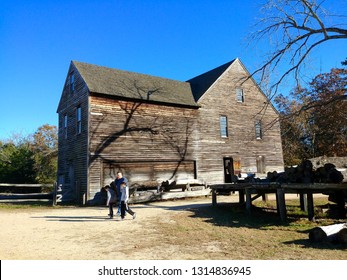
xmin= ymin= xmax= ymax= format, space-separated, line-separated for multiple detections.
xmin=196 ymin=60 xmax=283 ymax=183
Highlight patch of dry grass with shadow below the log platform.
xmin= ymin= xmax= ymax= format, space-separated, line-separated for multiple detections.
xmin=154 ymin=198 xmax=347 ymax=260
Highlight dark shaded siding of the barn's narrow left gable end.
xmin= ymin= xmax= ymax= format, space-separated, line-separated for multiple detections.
xmin=57 ymin=64 xmax=89 ymax=204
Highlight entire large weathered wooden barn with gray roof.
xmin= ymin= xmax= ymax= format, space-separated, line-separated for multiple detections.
xmin=57 ymin=59 xmax=283 ymax=204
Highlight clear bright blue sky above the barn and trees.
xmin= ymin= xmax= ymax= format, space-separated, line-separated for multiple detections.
xmin=0 ymin=0 xmax=347 ymax=139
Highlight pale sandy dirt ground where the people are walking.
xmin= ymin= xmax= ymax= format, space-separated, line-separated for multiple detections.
xmin=0 ymin=197 xmax=237 ymax=260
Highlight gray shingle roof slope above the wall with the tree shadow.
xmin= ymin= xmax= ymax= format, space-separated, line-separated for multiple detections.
xmin=72 ymin=61 xmax=198 ymax=107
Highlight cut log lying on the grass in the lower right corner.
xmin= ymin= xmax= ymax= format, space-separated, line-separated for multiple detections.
xmin=309 ymin=223 xmax=347 ymax=242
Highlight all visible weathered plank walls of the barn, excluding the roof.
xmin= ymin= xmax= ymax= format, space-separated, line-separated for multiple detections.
xmin=58 ymin=61 xmax=283 ymax=203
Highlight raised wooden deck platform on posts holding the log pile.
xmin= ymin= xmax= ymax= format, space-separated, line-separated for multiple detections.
xmin=209 ymin=183 xmax=347 ymax=221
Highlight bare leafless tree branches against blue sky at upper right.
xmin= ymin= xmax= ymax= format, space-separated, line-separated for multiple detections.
xmin=250 ymin=0 xmax=347 ymax=99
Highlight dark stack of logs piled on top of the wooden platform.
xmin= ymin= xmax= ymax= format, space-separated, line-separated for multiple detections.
xmin=267 ymin=160 xmax=343 ymax=184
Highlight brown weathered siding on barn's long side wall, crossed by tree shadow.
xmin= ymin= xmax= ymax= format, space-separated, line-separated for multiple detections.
xmin=89 ymin=94 xmax=198 ymax=194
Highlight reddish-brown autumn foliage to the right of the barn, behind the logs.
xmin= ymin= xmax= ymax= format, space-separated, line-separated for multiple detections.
xmin=275 ymin=68 xmax=347 ymax=165
